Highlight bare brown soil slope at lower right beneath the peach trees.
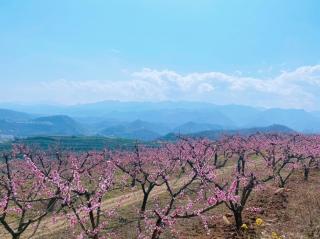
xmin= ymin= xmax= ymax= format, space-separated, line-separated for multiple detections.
xmin=175 ymin=171 xmax=320 ymax=239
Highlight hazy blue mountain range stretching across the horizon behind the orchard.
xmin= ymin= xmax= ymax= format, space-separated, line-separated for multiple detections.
xmin=0 ymin=101 xmax=320 ymax=140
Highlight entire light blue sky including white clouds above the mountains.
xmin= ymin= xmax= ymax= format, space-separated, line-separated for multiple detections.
xmin=0 ymin=0 xmax=320 ymax=109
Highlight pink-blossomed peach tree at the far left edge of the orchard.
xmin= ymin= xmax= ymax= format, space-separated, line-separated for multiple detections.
xmin=0 ymin=146 xmax=59 ymax=238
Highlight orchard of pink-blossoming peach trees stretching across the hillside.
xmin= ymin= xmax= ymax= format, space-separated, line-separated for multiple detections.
xmin=0 ymin=134 xmax=320 ymax=239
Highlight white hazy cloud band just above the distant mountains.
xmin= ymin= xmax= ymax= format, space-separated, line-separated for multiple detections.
xmin=0 ymin=65 xmax=320 ymax=109
